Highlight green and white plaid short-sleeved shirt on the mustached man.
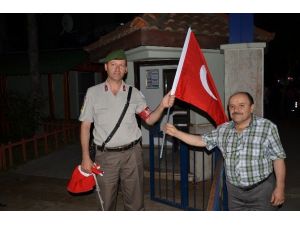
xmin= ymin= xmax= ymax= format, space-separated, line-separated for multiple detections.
xmin=202 ymin=115 xmax=286 ymax=187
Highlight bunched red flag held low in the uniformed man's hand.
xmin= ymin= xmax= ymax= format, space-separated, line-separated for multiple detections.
xmin=67 ymin=165 xmax=96 ymax=193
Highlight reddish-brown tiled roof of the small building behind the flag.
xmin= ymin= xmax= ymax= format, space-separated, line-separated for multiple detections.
xmin=85 ymin=13 xmax=274 ymax=60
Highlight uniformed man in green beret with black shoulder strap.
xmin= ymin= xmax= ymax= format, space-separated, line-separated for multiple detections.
xmin=79 ymin=50 xmax=175 ymax=210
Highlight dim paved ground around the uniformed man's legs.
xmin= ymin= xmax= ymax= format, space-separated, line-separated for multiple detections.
xmin=0 ymin=144 xmax=178 ymax=211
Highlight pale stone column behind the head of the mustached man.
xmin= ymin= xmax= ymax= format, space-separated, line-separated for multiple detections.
xmin=221 ymin=43 xmax=266 ymax=116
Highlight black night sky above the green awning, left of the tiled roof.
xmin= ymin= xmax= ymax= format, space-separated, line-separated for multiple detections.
xmin=0 ymin=13 xmax=138 ymax=52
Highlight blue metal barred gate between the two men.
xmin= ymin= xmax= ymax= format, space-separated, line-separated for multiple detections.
xmin=149 ymin=126 xmax=224 ymax=210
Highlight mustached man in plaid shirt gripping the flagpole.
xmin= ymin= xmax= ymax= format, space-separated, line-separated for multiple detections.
xmin=165 ymin=92 xmax=286 ymax=210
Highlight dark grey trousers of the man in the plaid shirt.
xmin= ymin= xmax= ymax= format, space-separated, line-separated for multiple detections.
xmin=226 ymin=174 xmax=278 ymax=211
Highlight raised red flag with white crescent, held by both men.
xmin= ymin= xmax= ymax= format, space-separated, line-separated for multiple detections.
xmin=171 ymin=28 xmax=228 ymax=125
